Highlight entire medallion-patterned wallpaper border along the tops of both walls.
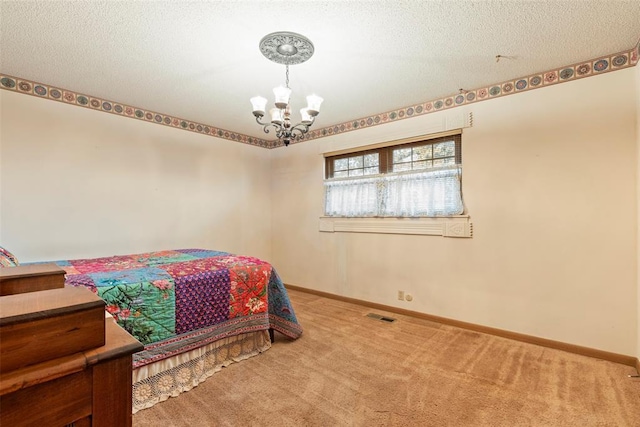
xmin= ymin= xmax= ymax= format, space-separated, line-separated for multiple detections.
xmin=0 ymin=41 xmax=640 ymax=148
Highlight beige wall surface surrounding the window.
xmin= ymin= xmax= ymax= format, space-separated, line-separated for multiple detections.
xmin=271 ymin=67 xmax=638 ymax=355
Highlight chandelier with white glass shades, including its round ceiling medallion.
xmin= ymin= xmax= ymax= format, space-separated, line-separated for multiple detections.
xmin=251 ymin=31 xmax=323 ymax=146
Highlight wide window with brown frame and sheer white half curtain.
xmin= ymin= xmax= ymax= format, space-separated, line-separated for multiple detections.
xmin=324 ymin=135 xmax=464 ymax=217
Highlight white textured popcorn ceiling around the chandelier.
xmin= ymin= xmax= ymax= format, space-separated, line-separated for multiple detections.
xmin=0 ymin=0 xmax=640 ymax=143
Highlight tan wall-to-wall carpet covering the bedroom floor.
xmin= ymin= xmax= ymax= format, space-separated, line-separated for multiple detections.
xmin=133 ymin=291 xmax=640 ymax=427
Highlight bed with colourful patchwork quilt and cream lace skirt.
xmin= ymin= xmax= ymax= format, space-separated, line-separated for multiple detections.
xmin=47 ymin=249 xmax=302 ymax=413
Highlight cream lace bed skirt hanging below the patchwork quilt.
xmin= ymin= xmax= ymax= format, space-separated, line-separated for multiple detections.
xmin=133 ymin=330 xmax=271 ymax=414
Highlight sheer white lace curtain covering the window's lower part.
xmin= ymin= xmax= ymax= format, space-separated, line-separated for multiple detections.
xmin=324 ymin=165 xmax=464 ymax=217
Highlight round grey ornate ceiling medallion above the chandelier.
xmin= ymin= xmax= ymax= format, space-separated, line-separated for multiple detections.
xmin=260 ymin=31 xmax=313 ymax=65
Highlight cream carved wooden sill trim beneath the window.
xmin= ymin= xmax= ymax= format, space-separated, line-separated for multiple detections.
xmin=319 ymin=215 xmax=473 ymax=237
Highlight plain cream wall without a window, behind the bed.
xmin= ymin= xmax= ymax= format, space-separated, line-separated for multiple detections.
xmin=0 ymin=91 xmax=271 ymax=261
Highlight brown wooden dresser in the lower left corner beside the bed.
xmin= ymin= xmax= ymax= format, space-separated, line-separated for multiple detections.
xmin=0 ymin=267 xmax=143 ymax=427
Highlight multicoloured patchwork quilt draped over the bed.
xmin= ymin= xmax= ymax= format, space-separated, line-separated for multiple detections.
xmin=56 ymin=249 xmax=302 ymax=368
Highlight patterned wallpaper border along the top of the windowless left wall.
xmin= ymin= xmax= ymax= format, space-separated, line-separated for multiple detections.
xmin=0 ymin=73 xmax=276 ymax=148
